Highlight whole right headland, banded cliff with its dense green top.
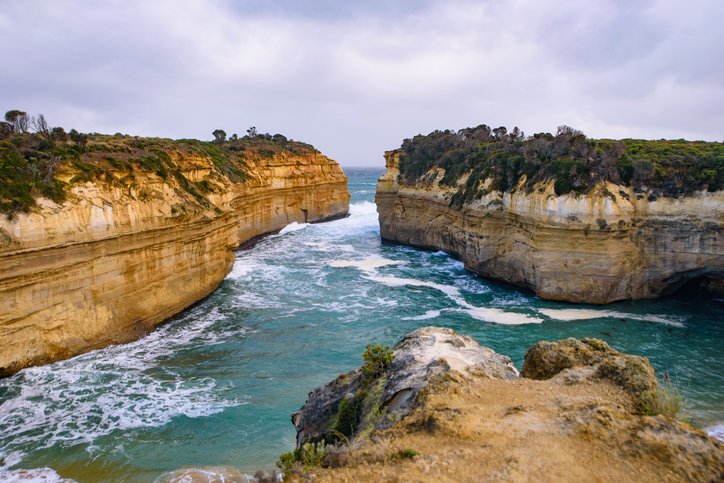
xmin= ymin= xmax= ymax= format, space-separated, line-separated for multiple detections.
xmin=375 ymin=127 xmax=724 ymax=304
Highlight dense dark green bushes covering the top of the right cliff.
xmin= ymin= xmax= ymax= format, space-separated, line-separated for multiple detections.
xmin=397 ymin=124 xmax=724 ymax=206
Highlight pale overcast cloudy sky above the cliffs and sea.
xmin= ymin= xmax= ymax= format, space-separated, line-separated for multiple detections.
xmin=0 ymin=0 xmax=724 ymax=167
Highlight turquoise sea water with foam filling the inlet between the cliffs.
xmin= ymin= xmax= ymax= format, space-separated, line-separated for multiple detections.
xmin=0 ymin=169 xmax=724 ymax=482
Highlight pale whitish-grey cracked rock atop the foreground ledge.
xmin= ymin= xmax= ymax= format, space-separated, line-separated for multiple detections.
xmin=382 ymin=327 xmax=518 ymax=414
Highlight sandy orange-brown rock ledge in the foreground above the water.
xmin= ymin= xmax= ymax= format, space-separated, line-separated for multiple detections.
xmin=285 ymin=327 xmax=724 ymax=482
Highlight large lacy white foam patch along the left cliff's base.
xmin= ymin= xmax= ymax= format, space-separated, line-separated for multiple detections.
xmin=0 ymin=308 xmax=248 ymax=458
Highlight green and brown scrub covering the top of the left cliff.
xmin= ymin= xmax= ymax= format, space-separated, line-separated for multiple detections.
xmin=0 ymin=110 xmax=316 ymax=218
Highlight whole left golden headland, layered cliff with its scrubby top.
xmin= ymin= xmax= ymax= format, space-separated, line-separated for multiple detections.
xmin=0 ymin=133 xmax=349 ymax=375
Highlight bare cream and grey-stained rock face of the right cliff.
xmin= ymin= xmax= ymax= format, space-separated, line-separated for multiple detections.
xmin=376 ymin=151 xmax=724 ymax=304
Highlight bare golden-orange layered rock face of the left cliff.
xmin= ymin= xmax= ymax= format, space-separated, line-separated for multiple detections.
xmin=0 ymin=151 xmax=349 ymax=375
